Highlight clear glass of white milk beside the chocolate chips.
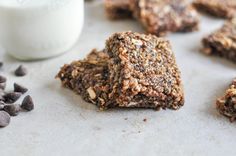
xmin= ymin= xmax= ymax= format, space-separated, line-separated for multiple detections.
xmin=0 ymin=0 xmax=84 ymax=60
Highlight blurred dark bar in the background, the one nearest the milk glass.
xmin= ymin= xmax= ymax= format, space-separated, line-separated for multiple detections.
xmin=104 ymin=0 xmax=132 ymax=19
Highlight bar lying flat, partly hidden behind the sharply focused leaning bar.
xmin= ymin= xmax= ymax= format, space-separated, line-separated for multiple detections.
xmin=57 ymin=49 xmax=114 ymax=109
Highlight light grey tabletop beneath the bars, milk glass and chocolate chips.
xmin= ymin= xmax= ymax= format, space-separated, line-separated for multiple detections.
xmin=0 ymin=2 xmax=236 ymax=156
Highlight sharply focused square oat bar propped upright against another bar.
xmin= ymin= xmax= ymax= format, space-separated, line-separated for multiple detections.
xmin=105 ymin=32 xmax=184 ymax=110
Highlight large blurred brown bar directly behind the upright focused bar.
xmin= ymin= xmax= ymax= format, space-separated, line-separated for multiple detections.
xmin=131 ymin=0 xmax=199 ymax=36
